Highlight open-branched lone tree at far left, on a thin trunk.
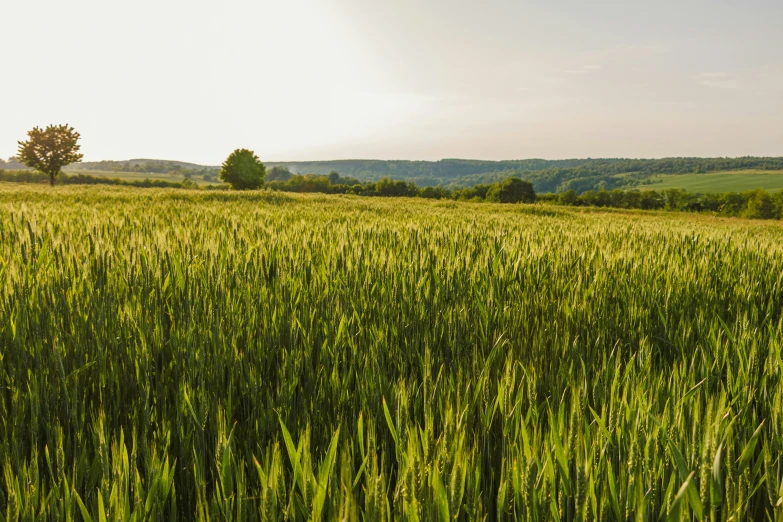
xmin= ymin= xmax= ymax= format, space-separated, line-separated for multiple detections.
xmin=18 ymin=124 xmax=83 ymax=186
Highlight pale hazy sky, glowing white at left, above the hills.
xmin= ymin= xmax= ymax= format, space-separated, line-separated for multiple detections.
xmin=0 ymin=0 xmax=783 ymax=164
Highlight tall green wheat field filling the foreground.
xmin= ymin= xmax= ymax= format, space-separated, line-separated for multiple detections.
xmin=0 ymin=184 xmax=783 ymax=522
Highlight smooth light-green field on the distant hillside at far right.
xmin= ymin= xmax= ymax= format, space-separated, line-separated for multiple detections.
xmin=641 ymin=170 xmax=783 ymax=194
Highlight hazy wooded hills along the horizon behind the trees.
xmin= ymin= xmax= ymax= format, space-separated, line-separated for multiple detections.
xmin=6 ymin=157 xmax=783 ymax=193
